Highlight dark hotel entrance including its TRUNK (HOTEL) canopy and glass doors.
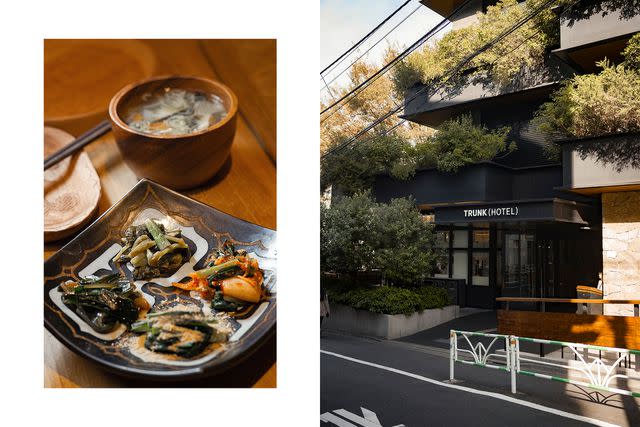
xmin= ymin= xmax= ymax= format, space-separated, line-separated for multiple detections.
xmin=430 ymin=199 xmax=602 ymax=309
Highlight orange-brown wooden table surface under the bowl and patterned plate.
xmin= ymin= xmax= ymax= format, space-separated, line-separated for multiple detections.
xmin=44 ymin=40 xmax=276 ymax=387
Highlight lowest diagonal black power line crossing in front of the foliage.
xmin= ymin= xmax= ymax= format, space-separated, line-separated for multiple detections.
xmin=321 ymin=0 xmax=560 ymax=159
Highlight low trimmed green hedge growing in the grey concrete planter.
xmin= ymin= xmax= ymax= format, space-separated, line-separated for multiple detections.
xmin=328 ymin=286 xmax=450 ymax=314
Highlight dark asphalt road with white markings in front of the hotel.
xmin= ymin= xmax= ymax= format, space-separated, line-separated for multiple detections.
xmin=320 ymin=332 xmax=640 ymax=427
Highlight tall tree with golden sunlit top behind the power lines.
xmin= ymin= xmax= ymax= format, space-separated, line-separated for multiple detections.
xmin=320 ymin=48 xmax=433 ymax=195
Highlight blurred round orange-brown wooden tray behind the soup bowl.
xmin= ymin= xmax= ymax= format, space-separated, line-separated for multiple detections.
xmin=44 ymin=40 xmax=156 ymax=135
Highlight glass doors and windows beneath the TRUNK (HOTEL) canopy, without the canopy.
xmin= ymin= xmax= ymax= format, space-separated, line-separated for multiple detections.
xmin=434 ymin=223 xmax=602 ymax=309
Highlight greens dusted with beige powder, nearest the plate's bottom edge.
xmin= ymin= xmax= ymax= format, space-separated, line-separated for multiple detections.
xmin=131 ymin=311 xmax=230 ymax=358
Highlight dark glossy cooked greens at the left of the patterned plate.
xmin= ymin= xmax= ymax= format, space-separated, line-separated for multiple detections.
xmin=58 ymin=273 xmax=146 ymax=333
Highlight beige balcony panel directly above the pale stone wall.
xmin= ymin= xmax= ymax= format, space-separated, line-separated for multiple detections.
xmin=559 ymin=134 xmax=640 ymax=194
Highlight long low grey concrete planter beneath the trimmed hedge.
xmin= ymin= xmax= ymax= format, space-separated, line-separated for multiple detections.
xmin=322 ymin=304 xmax=460 ymax=339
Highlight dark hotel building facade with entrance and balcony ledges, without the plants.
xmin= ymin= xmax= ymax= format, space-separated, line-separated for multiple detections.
xmin=374 ymin=0 xmax=640 ymax=308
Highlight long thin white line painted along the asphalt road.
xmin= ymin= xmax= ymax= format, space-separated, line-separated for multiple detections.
xmin=320 ymin=350 xmax=619 ymax=427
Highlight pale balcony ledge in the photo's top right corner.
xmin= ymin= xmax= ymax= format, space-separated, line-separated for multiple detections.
xmin=553 ymin=7 xmax=640 ymax=72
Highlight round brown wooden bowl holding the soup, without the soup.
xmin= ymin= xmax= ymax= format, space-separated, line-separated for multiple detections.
xmin=109 ymin=76 xmax=238 ymax=190
